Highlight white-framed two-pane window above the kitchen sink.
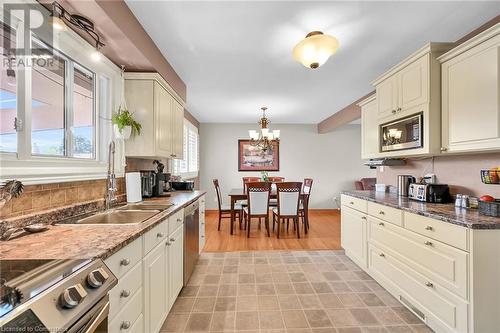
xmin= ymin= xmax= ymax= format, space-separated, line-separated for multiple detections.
xmin=31 ymin=40 xmax=95 ymax=159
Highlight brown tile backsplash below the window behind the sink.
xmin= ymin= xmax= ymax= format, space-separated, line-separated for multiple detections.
xmin=0 ymin=177 xmax=125 ymax=219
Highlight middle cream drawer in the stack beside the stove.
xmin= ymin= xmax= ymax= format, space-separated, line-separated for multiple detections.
xmin=109 ymin=261 xmax=142 ymax=319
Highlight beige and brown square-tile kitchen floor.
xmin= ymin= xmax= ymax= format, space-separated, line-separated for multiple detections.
xmin=161 ymin=251 xmax=432 ymax=333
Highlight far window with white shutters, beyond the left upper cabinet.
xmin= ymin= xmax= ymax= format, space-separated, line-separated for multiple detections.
xmin=172 ymin=120 xmax=199 ymax=178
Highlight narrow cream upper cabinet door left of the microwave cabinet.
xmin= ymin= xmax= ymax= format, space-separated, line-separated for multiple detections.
xmin=361 ymin=100 xmax=379 ymax=159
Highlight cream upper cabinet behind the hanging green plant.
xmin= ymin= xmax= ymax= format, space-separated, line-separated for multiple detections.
xmin=125 ymin=73 xmax=185 ymax=159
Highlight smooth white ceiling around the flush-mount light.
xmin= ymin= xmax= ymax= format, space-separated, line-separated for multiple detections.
xmin=127 ymin=0 xmax=500 ymax=123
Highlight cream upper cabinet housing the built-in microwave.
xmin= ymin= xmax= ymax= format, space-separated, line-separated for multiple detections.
xmin=363 ymin=43 xmax=453 ymax=158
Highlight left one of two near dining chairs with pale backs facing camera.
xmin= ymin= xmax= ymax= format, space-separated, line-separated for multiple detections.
xmin=243 ymin=182 xmax=271 ymax=237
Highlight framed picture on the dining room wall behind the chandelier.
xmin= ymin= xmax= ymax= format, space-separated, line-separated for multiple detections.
xmin=238 ymin=140 xmax=280 ymax=171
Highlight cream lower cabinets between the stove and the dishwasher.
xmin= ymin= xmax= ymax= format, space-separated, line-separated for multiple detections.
xmin=105 ymin=209 xmax=188 ymax=333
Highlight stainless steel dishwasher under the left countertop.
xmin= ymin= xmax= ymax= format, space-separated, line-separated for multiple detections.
xmin=184 ymin=201 xmax=200 ymax=285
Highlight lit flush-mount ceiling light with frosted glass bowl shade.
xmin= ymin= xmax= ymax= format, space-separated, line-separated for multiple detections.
xmin=293 ymin=31 xmax=339 ymax=69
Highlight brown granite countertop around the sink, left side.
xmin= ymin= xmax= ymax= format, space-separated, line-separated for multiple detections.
xmin=0 ymin=191 xmax=205 ymax=260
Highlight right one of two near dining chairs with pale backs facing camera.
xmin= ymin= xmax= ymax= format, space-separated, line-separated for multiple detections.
xmin=273 ymin=182 xmax=302 ymax=238
